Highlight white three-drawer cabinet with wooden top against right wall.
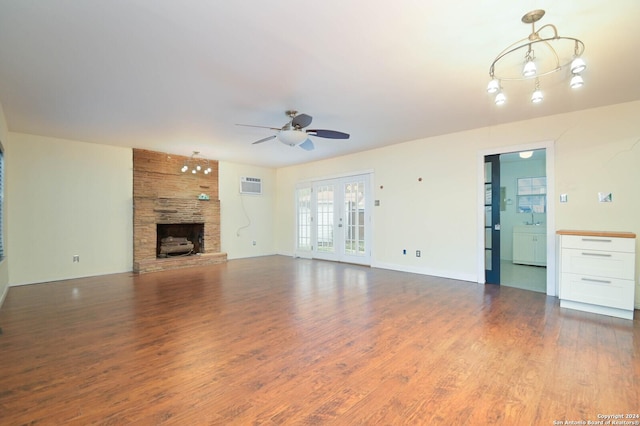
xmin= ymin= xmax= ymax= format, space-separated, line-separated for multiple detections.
xmin=558 ymin=231 xmax=636 ymax=319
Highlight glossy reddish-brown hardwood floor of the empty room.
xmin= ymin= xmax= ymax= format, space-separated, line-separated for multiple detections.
xmin=0 ymin=256 xmax=640 ymax=425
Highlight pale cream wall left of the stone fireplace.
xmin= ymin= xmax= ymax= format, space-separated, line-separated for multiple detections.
xmin=5 ymin=133 xmax=133 ymax=285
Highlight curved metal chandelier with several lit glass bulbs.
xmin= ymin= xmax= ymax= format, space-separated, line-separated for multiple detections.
xmin=487 ymin=9 xmax=587 ymax=105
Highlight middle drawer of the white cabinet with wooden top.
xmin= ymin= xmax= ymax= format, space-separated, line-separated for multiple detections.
xmin=560 ymin=249 xmax=636 ymax=280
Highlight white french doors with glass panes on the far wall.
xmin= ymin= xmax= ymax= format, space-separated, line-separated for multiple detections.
xmin=296 ymin=174 xmax=371 ymax=265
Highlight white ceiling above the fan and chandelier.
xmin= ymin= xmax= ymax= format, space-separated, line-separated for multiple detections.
xmin=0 ymin=0 xmax=640 ymax=167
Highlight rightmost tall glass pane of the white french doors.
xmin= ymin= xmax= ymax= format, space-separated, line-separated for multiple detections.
xmin=344 ymin=178 xmax=365 ymax=255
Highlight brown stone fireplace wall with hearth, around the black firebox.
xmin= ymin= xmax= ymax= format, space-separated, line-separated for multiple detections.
xmin=133 ymin=149 xmax=227 ymax=273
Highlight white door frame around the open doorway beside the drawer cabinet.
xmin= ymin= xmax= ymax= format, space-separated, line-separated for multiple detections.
xmin=476 ymin=141 xmax=558 ymax=296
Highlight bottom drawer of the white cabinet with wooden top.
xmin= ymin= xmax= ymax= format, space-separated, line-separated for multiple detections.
xmin=560 ymin=274 xmax=634 ymax=310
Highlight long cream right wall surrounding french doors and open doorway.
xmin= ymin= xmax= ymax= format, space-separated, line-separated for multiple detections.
xmin=276 ymin=101 xmax=640 ymax=294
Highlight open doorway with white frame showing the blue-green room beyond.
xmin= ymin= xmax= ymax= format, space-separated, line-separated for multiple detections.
xmin=478 ymin=142 xmax=557 ymax=296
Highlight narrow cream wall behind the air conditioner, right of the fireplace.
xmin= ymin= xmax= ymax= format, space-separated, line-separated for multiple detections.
xmin=218 ymin=161 xmax=276 ymax=259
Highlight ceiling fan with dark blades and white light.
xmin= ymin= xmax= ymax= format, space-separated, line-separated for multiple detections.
xmin=238 ymin=110 xmax=349 ymax=151
